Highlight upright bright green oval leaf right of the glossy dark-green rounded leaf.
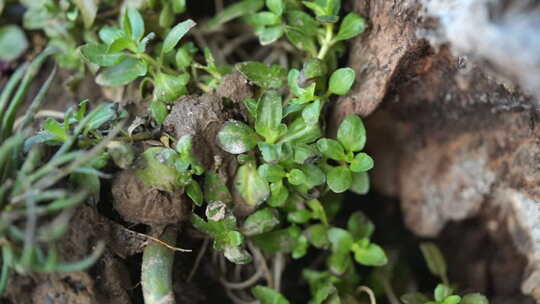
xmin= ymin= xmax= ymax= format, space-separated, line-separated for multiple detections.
xmin=255 ymin=90 xmax=283 ymax=143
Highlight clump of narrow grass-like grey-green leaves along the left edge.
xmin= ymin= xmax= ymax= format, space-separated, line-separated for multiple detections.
xmin=0 ymin=49 xmax=115 ymax=291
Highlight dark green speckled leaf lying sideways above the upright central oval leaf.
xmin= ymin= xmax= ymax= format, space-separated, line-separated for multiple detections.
xmin=236 ymin=61 xmax=286 ymax=89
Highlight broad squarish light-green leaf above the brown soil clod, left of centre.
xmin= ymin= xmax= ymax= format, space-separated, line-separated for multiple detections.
xmin=153 ymin=73 xmax=190 ymax=103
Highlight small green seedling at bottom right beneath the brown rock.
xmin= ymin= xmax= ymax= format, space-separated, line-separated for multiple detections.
xmin=401 ymin=243 xmax=489 ymax=304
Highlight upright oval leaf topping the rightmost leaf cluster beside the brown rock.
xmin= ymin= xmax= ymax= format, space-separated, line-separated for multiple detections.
xmin=337 ymin=114 xmax=366 ymax=152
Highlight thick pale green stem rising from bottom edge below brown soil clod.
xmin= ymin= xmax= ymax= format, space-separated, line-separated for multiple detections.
xmin=141 ymin=227 xmax=177 ymax=304
